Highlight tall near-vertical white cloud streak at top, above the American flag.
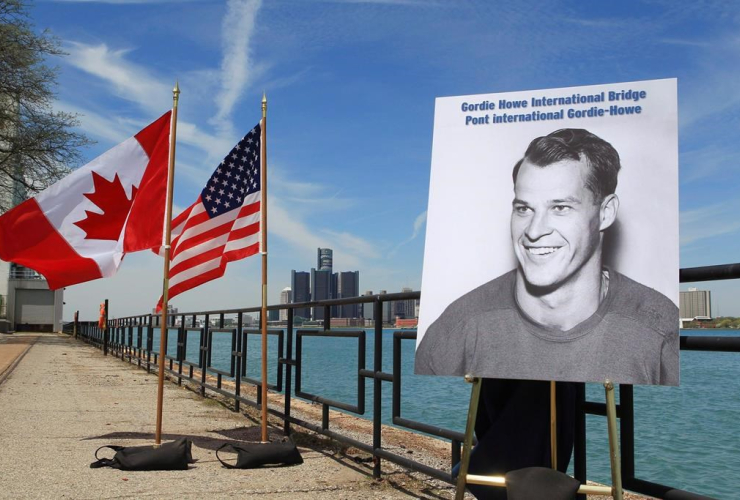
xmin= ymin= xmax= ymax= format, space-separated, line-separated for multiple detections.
xmin=212 ymin=0 xmax=262 ymax=132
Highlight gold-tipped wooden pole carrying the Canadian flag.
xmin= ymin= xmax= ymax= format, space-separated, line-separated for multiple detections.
xmin=154 ymin=82 xmax=180 ymax=444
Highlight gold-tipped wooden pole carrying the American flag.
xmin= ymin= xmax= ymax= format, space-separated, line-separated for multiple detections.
xmin=260 ymin=93 xmax=269 ymax=443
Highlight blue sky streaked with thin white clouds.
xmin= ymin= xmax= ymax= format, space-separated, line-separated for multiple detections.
xmin=21 ymin=0 xmax=740 ymax=319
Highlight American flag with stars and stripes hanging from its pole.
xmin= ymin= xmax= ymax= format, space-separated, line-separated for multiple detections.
xmin=157 ymin=124 xmax=261 ymax=309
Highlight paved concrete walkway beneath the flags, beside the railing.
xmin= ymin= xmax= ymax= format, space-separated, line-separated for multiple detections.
xmin=0 ymin=334 xmax=452 ymax=500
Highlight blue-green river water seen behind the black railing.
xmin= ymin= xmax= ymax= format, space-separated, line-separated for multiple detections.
xmin=149 ymin=329 xmax=740 ymax=498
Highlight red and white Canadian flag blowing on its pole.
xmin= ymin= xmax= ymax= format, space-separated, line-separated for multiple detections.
xmin=0 ymin=111 xmax=171 ymax=290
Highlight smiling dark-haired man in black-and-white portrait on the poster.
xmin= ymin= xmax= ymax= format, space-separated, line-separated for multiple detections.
xmin=415 ymin=129 xmax=679 ymax=385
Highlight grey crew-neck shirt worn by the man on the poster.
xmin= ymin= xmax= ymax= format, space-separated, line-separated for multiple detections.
xmin=415 ymin=270 xmax=679 ymax=385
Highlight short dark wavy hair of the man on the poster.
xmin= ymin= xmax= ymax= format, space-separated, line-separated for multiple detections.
xmin=512 ymin=128 xmax=621 ymax=203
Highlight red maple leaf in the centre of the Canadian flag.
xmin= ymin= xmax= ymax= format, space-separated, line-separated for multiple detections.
xmin=74 ymin=172 xmax=136 ymax=241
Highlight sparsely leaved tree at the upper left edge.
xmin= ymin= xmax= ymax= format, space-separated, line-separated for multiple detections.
xmin=0 ymin=0 xmax=90 ymax=213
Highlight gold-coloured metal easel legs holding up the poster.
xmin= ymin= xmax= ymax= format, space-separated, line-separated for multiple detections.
xmin=455 ymin=375 xmax=623 ymax=500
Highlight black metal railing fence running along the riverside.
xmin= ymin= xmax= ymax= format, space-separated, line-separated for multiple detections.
xmin=65 ymin=264 xmax=740 ymax=498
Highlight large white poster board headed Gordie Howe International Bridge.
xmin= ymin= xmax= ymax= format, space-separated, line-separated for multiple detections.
xmin=415 ymin=79 xmax=679 ymax=385
